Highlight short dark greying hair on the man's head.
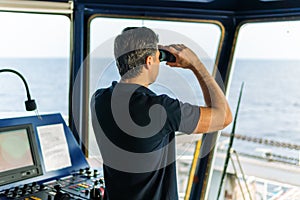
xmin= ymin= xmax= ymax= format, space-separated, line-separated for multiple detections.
xmin=114 ymin=27 xmax=158 ymax=79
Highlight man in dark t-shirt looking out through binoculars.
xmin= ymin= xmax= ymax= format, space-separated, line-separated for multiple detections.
xmin=91 ymin=27 xmax=232 ymax=200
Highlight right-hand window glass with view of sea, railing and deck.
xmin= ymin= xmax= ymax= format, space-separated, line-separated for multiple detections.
xmin=209 ymin=21 xmax=300 ymax=199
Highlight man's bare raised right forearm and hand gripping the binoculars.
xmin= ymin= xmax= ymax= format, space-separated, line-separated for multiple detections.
xmin=163 ymin=44 xmax=232 ymax=133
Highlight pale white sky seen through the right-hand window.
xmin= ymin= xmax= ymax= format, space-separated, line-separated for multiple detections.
xmin=236 ymin=21 xmax=300 ymax=59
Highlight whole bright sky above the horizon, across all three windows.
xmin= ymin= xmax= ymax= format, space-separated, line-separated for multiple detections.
xmin=0 ymin=12 xmax=300 ymax=59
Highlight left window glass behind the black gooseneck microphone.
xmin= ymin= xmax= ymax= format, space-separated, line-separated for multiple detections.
xmin=0 ymin=12 xmax=70 ymax=118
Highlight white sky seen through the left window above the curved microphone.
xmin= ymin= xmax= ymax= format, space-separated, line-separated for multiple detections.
xmin=0 ymin=12 xmax=70 ymax=58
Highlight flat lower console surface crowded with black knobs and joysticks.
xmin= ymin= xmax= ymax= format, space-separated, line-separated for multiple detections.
xmin=0 ymin=167 xmax=105 ymax=200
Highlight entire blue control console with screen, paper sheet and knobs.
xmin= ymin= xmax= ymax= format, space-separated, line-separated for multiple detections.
xmin=0 ymin=114 xmax=105 ymax=200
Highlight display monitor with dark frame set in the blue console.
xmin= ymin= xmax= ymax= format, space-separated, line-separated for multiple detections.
xmin=0 ymin=124 xmax=42 ymax=186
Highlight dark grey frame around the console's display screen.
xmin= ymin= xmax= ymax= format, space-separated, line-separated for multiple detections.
xmin=0 ymin=124 xmax=43 ymax=186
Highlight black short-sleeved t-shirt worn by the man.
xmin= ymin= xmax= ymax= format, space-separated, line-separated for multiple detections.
xmin=91 ymin=82 xmax=200 ymax=200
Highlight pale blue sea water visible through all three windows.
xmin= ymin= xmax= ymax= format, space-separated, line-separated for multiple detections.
xmin=0 ymin=58 xmax=300 ymax=157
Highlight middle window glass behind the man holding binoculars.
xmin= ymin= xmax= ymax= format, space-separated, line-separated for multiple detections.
xmin=88 ymin=17 xmax=221 ymax=198
